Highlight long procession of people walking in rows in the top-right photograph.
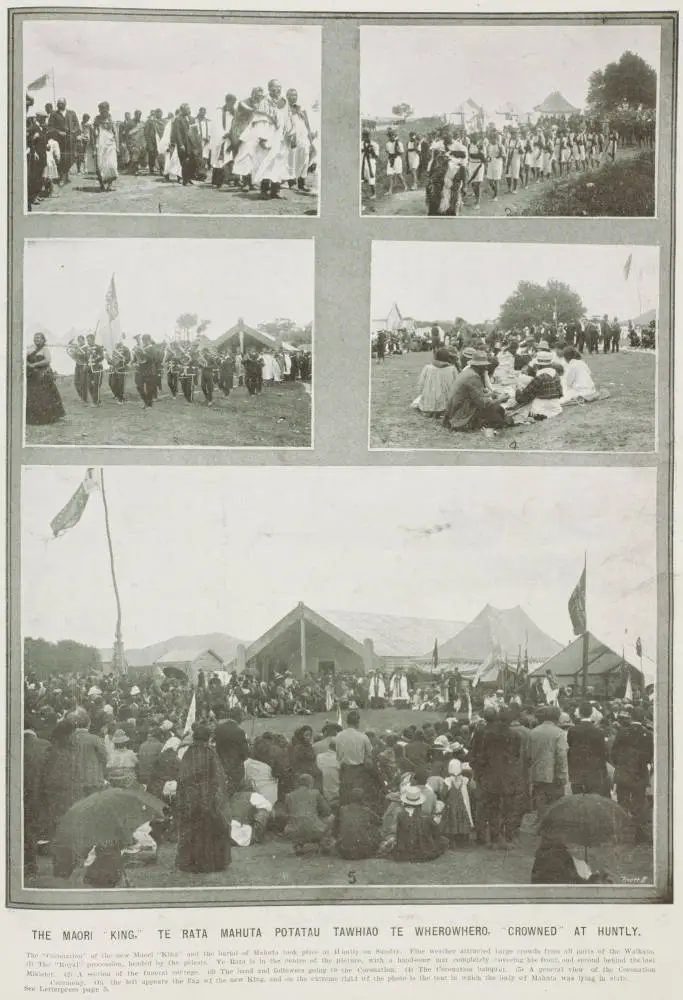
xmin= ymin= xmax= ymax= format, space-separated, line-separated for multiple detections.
xmin=361 ymin=116 xmax=655 ymax=215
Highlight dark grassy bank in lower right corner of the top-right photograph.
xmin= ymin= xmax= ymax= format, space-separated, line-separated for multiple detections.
xmin=522 ymin=151 xmax=655 ymax=217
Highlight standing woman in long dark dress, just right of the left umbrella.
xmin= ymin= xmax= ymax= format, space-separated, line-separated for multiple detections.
xmin=176 ymin=724 xmax=231 ymax=872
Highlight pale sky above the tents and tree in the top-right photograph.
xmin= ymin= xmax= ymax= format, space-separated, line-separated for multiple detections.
xmin=360 ymin=25 xmax=660 ymax=117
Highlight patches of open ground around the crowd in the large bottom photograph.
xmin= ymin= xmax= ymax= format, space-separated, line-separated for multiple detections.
xmin=26 ymin=708 xmax=652 ymax=889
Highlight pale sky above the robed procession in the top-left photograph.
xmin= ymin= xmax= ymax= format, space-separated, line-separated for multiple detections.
xmin=23 ymin=20 xmax=321 ymax=118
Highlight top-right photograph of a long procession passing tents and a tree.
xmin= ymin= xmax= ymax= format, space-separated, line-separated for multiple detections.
xmin=360 ymin=24 xmax=661 ymax=218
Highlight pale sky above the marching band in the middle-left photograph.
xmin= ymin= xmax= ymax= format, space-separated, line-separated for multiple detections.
xmin=24 ymin=239 xmax=314 ymax=352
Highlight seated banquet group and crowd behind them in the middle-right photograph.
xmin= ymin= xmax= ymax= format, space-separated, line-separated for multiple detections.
xmin=373 ymin=315 xmax=644 ymax=432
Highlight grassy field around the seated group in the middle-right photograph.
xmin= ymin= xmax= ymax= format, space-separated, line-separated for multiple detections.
xmin=370 ymin=351 xmax=655 ymax=451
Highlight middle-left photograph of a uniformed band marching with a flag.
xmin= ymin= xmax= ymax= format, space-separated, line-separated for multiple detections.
xmin=23 ymin=239 xmax=315 ymax=448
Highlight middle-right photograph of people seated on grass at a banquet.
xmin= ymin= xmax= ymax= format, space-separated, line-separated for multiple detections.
xmin=369 ymin=242 xmax=659 ymax=453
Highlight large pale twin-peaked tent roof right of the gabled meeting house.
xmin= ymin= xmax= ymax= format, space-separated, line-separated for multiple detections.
xmin=439 ymin=604 xmax=562 ymax=662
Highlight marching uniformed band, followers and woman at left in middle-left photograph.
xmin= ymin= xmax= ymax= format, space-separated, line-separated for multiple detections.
xmin=26 ymin=333 xmax=313 ymax=424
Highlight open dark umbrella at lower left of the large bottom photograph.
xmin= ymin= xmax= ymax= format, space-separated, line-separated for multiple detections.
xmin=53 ymin=788 xmax=164 ymax=857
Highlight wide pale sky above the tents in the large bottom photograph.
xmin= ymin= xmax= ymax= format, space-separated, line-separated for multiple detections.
xmin=21 ymin=466 xmax=656 ymax=666
